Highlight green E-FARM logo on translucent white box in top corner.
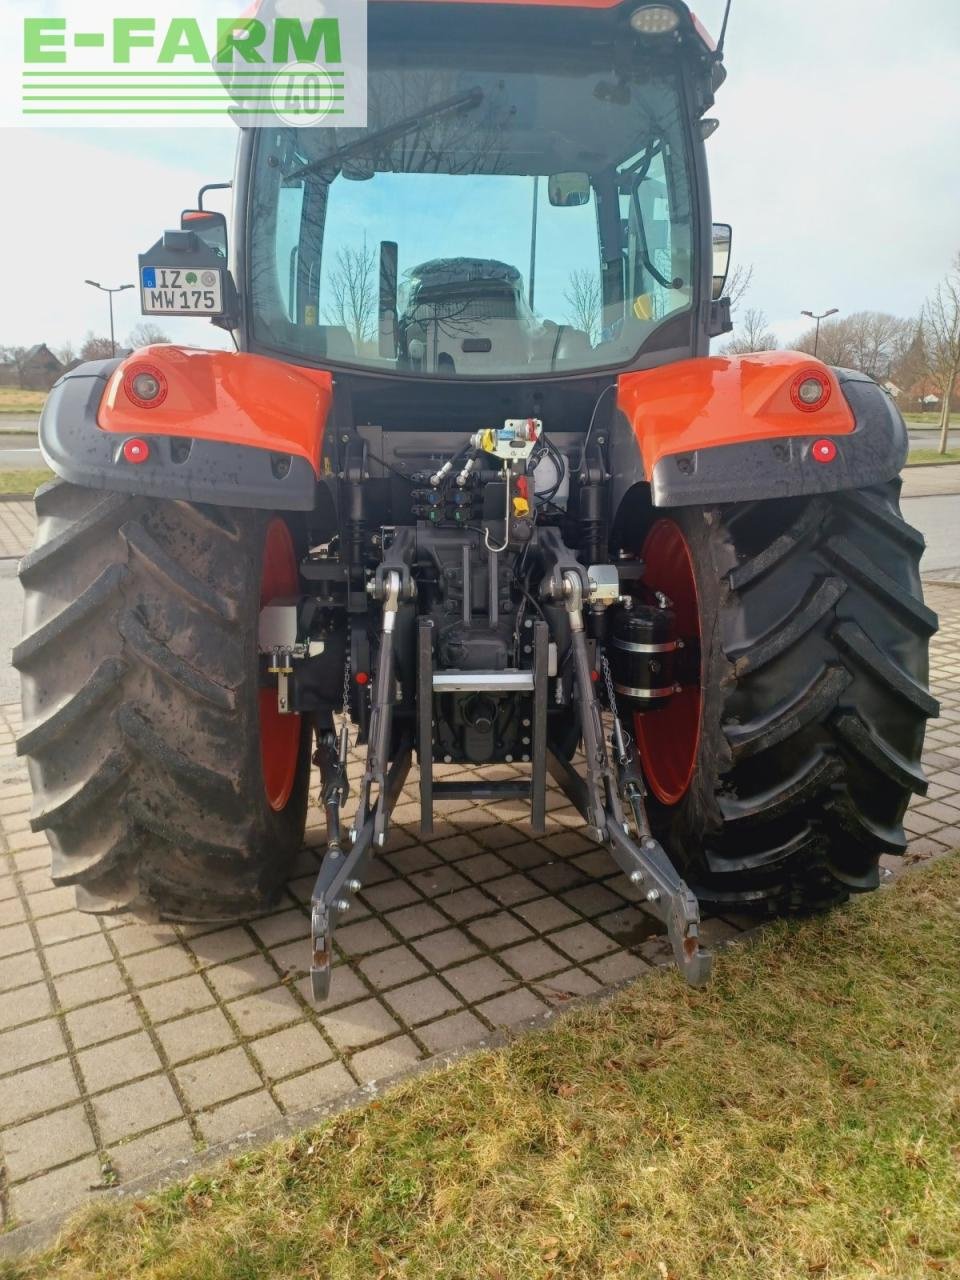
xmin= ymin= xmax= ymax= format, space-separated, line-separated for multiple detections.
xmin=0 ymin=0 xmax=366 ymax=128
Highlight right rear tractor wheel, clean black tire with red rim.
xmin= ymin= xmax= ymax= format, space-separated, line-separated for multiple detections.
xmin=636 ymin=480 xmax=938 ymax=913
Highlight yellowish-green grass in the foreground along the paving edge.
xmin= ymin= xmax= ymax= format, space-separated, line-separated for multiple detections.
xmin=0 ymin=855 xmax=960 ymax=1280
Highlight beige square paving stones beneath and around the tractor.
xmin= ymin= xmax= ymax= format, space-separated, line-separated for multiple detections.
xmin=0 ymin=555 xmax=960 ymax=1225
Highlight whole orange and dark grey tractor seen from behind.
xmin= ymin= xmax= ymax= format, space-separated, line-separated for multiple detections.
xmin=15 ymin=0 xmax=936 ymax=998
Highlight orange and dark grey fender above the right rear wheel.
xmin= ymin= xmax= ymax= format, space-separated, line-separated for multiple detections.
xmin=612 ymin=351 xmax=909 ymax=509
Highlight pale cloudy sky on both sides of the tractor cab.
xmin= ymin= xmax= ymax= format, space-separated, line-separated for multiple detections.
xmin=0 ymin=0 xmax=960 ymax=347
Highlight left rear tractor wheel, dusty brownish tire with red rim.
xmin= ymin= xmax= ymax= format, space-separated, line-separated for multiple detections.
xmin=14 ymin=480 xmax=311 ymax=920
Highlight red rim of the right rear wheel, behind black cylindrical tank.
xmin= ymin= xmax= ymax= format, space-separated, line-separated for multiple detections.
xmin=634 ymin=518 xmax=703 ymax=804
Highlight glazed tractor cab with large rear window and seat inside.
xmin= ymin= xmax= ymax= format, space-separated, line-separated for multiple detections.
xmin=237 ymin=3 xmax=722 ymax=380
